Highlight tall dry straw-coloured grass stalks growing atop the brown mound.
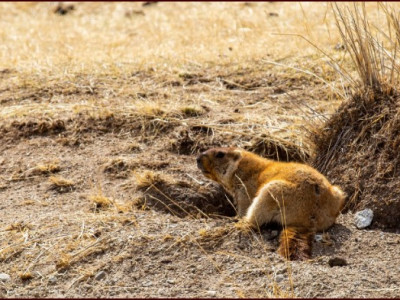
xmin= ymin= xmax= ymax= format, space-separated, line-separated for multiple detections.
xmin=333 ymin=3 xmax=400 ymax=92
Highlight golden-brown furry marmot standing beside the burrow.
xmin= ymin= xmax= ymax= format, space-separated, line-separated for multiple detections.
xmin=197 ymin=147 xmax=345 ymax=260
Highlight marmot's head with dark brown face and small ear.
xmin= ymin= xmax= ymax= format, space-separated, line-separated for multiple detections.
xmin=197 ymin=147 xmax=242 ymax=185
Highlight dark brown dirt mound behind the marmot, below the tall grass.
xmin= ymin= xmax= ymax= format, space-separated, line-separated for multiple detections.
xmin=314 ymin=90 xmax=400 ymax=229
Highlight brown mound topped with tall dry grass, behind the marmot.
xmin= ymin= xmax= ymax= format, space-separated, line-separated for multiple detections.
xmin=314 ymin=6 xmax=400 ymax=229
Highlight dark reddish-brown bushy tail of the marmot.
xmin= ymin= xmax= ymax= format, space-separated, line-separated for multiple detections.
xmin=278 ymin=227 xmax=314 ymax=260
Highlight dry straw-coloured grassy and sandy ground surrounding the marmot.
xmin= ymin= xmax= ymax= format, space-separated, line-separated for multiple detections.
xmin=0 ymin=2 xmax=400 ymax=297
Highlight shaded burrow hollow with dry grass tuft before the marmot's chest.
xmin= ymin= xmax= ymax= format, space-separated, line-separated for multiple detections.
xmin=135 ymin=171 xmax=235 ymax=218
